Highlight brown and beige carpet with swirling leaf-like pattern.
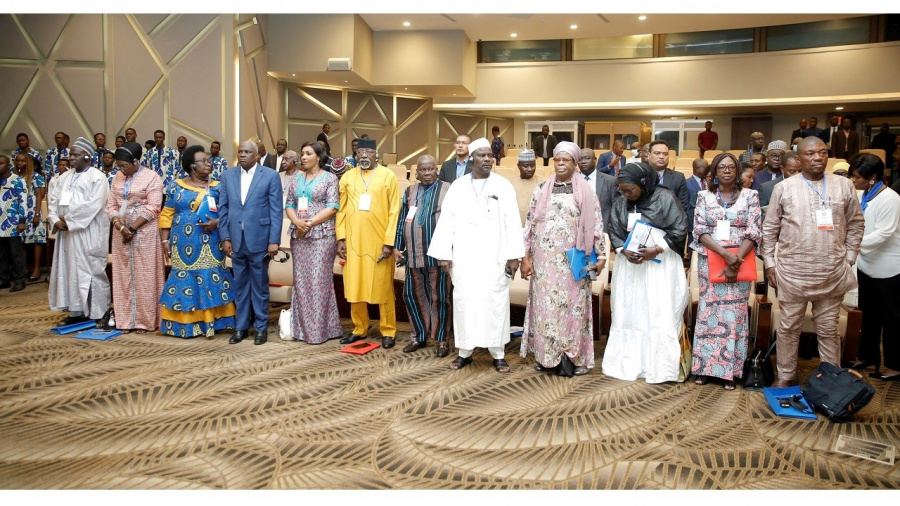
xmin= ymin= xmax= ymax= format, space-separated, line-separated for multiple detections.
xmin=0 ymin=284 xmax=900 ymax=489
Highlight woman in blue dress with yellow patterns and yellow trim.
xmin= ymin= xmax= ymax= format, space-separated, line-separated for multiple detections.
xmin=159 ymin=146 xmax=235 ymax=339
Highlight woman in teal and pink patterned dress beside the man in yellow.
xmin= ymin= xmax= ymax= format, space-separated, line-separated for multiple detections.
xmin=285 ymin=142 xmax=342 ymax=344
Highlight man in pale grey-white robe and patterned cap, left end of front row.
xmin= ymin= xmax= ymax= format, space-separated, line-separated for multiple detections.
xmin=47 ymin=137 xmax=110 ymax=325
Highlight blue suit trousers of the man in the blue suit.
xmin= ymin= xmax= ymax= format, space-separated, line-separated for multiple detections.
xmin=231 ymin=242 xmax=269 ymax=331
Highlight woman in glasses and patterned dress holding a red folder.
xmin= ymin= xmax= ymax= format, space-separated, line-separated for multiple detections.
xmin=691 ymin=153 xmax=762 ymax=390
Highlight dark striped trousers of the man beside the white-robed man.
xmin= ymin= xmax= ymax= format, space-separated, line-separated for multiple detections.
xmin=403 ymin=267 xmax=453 ymax=343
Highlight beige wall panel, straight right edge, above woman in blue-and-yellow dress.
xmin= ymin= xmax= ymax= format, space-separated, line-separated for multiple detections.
xmin=169 ymin=28 xmax=227 ymax=144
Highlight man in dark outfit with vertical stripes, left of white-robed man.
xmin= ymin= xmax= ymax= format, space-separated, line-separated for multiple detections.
xmin=394 ymin=155 xmax=453 ymax=358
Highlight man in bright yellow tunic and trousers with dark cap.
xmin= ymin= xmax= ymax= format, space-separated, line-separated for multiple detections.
xmin=336 ymin=138 xmax=400 ymax=348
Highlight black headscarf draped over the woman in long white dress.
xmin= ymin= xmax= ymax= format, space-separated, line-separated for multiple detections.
xmin=608 ymin=163 xmax=688 ymax=252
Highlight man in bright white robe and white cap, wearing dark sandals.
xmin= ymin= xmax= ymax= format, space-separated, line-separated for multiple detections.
xmin=428 ymin=137 xmax=525 ymax=373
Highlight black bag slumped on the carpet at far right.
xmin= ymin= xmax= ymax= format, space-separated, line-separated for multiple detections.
xmin=800 ymin=362 xmax=875 ymax=422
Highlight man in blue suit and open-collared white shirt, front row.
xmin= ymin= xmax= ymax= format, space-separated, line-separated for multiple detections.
xmin=219 ymin=141 xmax=283 ymax=344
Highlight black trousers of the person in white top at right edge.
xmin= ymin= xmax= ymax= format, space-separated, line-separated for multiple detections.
xmin=857 ymin=269 xmax=900 ymax=371
